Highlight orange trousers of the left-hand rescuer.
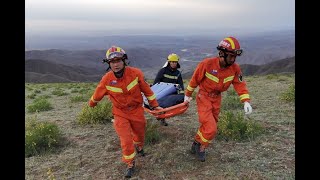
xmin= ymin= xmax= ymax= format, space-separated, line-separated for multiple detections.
xmin=113 ymin=114 xmax=146 ymax=164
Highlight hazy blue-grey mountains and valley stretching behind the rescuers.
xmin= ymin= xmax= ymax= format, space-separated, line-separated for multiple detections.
xmin=25 ymin=30 xmax=295 ymax=82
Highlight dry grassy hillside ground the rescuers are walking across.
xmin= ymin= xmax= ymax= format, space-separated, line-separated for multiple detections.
xmin=25 ymin=74 xmax=295 ymax=180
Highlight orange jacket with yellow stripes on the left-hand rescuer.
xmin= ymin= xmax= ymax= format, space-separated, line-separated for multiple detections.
xmin=89 ymin=66 xmax=159 ymax=116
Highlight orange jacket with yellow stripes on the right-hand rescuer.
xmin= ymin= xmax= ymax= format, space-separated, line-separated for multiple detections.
xmin=185 ymin=57 xmax=250 ymax=102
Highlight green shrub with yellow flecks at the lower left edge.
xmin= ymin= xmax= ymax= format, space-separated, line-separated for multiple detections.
xmin=25 ymin=118 xmax=62 ymax=157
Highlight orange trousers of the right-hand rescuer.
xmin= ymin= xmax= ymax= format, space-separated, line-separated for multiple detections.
xmin=195 ymin=91 xmax=221 ymax=148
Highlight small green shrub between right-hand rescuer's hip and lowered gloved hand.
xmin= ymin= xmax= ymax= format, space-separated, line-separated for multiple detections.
xmin=221 ymin=89 xmax=243 ymax=110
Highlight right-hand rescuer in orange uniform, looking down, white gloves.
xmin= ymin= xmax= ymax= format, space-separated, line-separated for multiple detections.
xmin=184 ymin=37 xmax=252 ymax=162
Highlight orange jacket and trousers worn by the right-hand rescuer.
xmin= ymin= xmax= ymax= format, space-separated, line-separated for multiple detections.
xmin=185 ymin=57 xmax=250 ymax=147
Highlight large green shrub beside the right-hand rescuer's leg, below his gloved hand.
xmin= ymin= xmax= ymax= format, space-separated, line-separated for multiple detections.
xmin=217 ymin=111 xmax=263 ymax=141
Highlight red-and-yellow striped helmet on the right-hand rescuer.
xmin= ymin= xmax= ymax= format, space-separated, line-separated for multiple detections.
xmin=217 ymin=36 xmax=242 ymax=56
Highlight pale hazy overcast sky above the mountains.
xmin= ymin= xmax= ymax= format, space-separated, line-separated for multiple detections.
xmin=25 ymin=0 xmax=295 ymax=36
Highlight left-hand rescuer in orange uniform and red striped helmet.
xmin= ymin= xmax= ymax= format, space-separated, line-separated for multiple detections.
xmin=89 ymin=46 xmax=162 ymax=178
